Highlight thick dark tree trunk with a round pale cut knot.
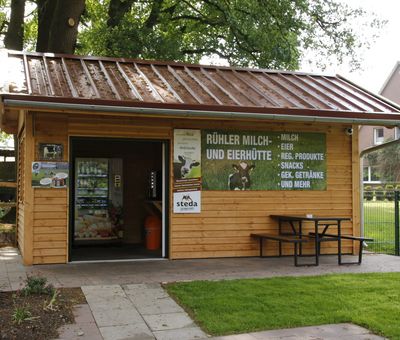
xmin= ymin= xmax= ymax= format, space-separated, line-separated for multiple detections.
xmin=47 ymin=0 xmax=85 ymax=54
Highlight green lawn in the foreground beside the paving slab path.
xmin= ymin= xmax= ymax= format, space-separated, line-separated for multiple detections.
xmin=166 ymin=273 xmax=400 ymax=339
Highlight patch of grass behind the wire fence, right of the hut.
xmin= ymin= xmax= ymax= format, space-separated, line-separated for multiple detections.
xmin=364 ymin=201 xmax=395 ymax=254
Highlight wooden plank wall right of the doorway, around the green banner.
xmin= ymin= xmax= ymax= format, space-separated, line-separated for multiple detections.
xmin=171 ymin=119 xmax=358 ymax=259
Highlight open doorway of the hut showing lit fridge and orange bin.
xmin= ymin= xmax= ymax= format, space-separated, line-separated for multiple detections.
xmin=69 ymin=137 xmax=167 ymax=261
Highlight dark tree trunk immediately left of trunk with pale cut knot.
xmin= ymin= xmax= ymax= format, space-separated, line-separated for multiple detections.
xmin=36 ymin=0 xmax=57 ymax=52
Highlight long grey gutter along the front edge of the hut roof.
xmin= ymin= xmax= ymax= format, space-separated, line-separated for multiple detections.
xmin=4 ymin=99 xmax=399 ymax=126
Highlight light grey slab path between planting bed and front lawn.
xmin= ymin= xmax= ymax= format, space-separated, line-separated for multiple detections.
xmin=82 ymin=283 xmax=207 ymax=340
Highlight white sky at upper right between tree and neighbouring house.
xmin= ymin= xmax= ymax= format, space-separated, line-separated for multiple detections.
xmin=305 ymin=0 xmax=400 ymax=93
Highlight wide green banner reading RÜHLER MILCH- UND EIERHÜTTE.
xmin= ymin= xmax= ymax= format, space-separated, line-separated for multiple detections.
xmin=201 ymin=130 xmax=327 ymax=190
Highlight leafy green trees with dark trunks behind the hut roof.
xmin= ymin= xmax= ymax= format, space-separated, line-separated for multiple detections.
xmin=0 ymin=0 xmax=382 ymax=69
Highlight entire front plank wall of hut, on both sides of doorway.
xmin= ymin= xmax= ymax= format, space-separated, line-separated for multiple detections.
xmin=26 ymin=113 xmax=358 ymax=263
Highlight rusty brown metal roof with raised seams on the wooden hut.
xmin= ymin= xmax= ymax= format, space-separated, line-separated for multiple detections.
xmin=0 ymin=51 xmax=400 ymax=116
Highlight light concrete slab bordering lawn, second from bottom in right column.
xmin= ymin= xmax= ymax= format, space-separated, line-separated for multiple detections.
xmin=143 ymin=313 xmax=196 ymax=331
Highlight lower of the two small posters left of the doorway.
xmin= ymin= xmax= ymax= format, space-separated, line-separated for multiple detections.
xmin=32 ymin=162 xmax=69 ymax=188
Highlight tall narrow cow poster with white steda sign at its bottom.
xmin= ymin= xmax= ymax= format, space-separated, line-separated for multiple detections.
xmin=173 ymin=129 xmax=202 ymax=213
